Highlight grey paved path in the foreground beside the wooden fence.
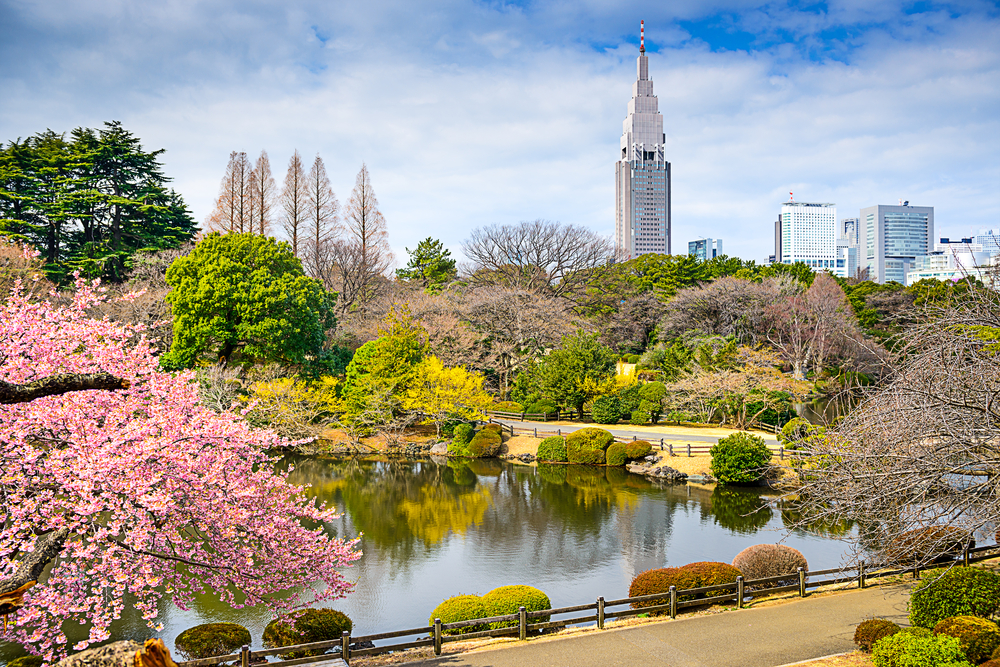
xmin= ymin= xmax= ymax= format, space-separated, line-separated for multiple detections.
xmin=402 ymin=586 xmax=909 ymax=667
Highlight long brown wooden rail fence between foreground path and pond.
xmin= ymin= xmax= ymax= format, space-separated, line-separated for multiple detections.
xmin=177 ymin=544 xmax=1000 ymax=667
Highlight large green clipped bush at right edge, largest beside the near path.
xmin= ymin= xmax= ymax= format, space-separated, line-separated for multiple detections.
xmin=910 ymin=567 xmax=1000 ymax=628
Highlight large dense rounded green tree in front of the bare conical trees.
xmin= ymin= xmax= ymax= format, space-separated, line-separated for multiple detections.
xmin=162 ymin=233 xmax=336 ymax=368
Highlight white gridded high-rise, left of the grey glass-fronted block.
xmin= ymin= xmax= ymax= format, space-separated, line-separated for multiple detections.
xmin=775 ymin=201 xmax=837 ymax=273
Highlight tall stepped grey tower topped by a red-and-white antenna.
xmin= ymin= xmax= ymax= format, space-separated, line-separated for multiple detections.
xmin=615 ymin=21 xmax=670 ymax=259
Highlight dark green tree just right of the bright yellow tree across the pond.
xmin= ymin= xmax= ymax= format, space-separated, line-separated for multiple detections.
xmin=539 ymin=331 xmax=617 ymax=419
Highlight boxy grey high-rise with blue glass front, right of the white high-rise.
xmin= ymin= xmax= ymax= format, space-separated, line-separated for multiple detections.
xmin=859 ymin=202 xmax=934 ymax=285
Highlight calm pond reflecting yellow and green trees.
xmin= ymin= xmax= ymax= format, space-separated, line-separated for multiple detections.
xmin=0 ymin=457 xmax=856 ymax=663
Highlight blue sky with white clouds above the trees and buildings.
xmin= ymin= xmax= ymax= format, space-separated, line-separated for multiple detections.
xmin=0 ymin=0 xmax=1000 ymax=264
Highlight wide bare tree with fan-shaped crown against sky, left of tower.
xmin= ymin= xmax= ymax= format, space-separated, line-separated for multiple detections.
xmin=462 ymin=220 xmax=614 ymax=298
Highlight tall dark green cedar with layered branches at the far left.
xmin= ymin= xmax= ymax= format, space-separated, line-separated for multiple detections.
xmin=0 ymin=121 xmax=196 ymax=281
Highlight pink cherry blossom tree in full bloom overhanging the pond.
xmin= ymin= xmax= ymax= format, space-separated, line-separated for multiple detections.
xmin=0 ymin=280 xmax=360 ymax=662
